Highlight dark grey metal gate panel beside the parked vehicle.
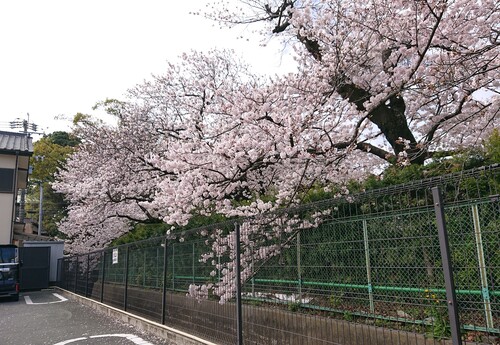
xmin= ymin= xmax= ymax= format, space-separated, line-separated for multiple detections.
xmin=19 ymin=247 xmax=50 ymax=290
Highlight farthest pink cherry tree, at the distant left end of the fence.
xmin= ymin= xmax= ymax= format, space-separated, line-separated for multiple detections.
xmin=53 ymin=113 xmax=161 ymax=252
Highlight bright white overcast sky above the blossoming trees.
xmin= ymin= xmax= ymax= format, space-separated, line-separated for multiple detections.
xmin=0 ymin=0 xmax=291 ymax=133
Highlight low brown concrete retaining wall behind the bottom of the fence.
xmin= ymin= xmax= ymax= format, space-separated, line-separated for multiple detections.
xmin=72 ymin=284 xmax=462 ymax=345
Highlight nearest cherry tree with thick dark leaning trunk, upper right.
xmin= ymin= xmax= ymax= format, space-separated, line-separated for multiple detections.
xmin=207 ymin=0 xmax=500 ymax=163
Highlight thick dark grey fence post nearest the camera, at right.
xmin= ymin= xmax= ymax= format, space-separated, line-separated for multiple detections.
xmin=432 ymin=187 xmax=462 ymax=345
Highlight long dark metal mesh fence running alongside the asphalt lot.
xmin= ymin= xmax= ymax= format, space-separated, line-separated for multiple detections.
xmin=59 ymin=165 xmax=500 ymax=344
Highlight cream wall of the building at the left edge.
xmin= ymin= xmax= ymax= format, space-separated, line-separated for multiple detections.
xmin=0 ymin=155 xmax=16 ymax=244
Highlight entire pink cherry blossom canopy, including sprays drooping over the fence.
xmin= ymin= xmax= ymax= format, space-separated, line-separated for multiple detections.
xmin=54 ymin=0 xmax=500 ymax=299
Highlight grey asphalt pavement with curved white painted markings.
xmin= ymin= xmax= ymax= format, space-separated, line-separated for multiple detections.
xmin=0 ymin=289 xmax=171 ymax=345
